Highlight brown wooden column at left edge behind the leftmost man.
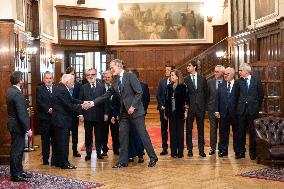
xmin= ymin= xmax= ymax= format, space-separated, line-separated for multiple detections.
xmin=0 ymin=21 xmax=15 ymax=164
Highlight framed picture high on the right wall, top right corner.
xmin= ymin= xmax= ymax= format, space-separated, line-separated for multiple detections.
xmin=254 ymin=0 xmax=279 ymax=23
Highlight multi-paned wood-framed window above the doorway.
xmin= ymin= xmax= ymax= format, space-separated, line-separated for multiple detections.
xmin=59 ymin=17 xmax=102 ymax=41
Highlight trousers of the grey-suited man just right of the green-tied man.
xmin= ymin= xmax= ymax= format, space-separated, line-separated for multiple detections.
xmin=208 ymin=111 xmax=220 ymax=150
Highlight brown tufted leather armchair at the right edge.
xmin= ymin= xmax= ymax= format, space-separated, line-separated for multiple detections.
xmin=254 ymin=117 xmax=284 ymax=163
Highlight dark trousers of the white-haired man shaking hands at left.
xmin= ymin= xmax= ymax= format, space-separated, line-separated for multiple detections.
xmin=55 ymin=127 xmax=70 ymax=167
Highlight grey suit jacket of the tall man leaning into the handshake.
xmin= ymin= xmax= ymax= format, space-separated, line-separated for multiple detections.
xmin=93 ymin=71 xmax=145 ymax=118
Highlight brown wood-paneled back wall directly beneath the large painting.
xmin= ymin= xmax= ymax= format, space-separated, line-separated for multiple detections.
xmin=110 ymin=44 xmax=211 ymax=97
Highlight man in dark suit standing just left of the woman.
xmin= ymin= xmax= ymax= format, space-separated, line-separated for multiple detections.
xmin=156 ymin=65 xmax=174 ymax=155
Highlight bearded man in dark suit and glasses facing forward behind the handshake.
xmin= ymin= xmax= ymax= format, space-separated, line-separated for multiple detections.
xmin=79 ymin=68 xmax=108 ymax=161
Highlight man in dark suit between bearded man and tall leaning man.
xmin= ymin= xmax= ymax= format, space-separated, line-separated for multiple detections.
xmin=102 ymin=70 xmax=120 ymax=156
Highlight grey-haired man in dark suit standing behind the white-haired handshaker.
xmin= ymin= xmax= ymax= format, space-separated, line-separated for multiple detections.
xmin=36 ymin=71 xmax=56 ymax=165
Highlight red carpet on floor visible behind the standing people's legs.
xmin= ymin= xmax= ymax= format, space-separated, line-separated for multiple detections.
xmin=81 ymin=126 xmax=210 ymax=151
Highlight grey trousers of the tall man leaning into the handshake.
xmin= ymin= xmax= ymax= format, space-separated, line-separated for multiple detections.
xmin=119 ymin=109 xmax=157 ymax=164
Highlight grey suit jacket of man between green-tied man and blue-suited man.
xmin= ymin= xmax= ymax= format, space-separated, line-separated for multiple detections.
xmin=207 ymin=79 xmax=222 ymax=112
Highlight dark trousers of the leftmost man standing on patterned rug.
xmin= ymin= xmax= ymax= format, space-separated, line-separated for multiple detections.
xmin=10 ymin=132 xmax=25 ymax=177
